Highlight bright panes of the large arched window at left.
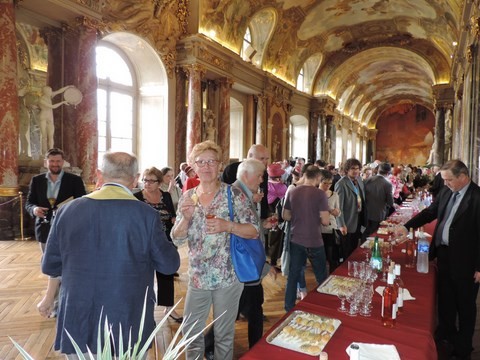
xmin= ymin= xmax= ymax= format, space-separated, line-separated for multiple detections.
xmin=96 ymin=44 xmax=136 ymax=164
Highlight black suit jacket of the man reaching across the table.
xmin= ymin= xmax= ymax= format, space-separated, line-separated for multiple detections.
xmin=405 ymin=182 xmax=480 ymax=278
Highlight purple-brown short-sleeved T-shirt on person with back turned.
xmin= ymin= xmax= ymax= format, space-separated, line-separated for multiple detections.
xmin=285 ymin=185 xmax=329 ymax=247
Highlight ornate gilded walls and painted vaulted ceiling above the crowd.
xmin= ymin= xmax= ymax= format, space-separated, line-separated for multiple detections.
xmin=0 ymin=0 xmax=480 ymax=358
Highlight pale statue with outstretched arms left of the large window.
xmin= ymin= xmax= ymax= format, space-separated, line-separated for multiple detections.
xmin=38 ymin=85 xmax=74 ymax=154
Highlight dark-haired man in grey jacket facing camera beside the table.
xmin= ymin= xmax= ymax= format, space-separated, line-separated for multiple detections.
xmin=335 ymin=158 xmax=367 ymax=259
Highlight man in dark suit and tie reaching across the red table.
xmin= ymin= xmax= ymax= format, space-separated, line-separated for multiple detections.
xmin=402 ymin=160 xmax=480 ymax=359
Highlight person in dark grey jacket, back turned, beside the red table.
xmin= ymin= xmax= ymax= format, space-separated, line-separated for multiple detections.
xmin=363 ymin=163 xmax=393 ymax=239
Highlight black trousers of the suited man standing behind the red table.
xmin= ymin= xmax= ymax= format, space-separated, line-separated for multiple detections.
xmin=436 ymin=246 xmax=478 ymax=357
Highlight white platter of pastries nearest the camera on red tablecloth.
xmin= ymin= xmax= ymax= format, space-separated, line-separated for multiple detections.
xmin=267 ymin=310 xmax=341 ymax=356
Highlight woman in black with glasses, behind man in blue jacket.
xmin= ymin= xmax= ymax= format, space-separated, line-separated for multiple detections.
xmin=135 ymin=167 xmax=183 ymax=323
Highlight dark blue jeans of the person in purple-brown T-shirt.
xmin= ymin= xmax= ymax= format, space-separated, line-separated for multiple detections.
xmin=285 ymin=242 xmax=327 ymax=312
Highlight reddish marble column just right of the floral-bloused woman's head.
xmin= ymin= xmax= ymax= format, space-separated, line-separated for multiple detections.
xmin=217 ymin=78 xmax=233 ymax=164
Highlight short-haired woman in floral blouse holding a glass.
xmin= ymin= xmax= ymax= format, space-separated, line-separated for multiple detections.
xmin=172 ymin=141 xmax=259 ymax=360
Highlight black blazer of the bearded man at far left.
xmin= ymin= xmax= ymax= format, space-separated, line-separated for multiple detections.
xmin=25 ymin=172 xmax=86 ymax=243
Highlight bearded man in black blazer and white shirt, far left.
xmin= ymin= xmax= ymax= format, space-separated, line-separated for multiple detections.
xmin=25 ymin=148 xmax=86 ymax=252
